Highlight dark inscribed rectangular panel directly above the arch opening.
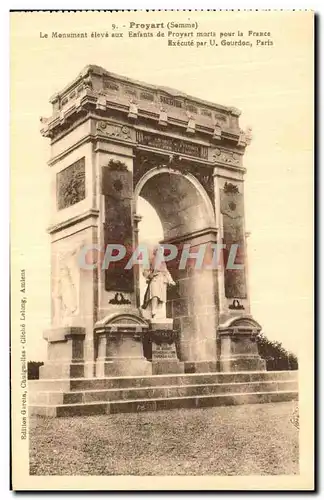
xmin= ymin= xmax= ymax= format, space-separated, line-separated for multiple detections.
xmin=136 ymin=130 xmax=208 ymax=160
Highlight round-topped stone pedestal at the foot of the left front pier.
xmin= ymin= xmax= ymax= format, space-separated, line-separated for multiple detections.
xmin=95 ymin=314 xmax=152 ymax=377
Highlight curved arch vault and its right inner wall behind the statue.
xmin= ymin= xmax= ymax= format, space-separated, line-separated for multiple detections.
xmin=134 ymin=166 xmax=218 ymax=362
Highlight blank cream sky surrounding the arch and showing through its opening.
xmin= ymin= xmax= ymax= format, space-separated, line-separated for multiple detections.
xmin=11 ymin=12 xmax=313 ymax=360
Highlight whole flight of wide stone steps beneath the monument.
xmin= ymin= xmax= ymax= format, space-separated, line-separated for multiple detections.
xmin=28 ymin=371 xmax=298 ymax=416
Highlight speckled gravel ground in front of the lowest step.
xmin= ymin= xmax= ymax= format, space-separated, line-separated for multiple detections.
xmin=30 ymin=402 xmax=298 ymax=475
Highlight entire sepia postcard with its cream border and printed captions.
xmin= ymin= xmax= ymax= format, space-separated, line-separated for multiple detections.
xmin=10 ymin=11 xmax=314 ymax=490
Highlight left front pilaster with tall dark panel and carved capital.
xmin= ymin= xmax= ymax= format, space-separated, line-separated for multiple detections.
xmin=93 ymin=119 xmax=136 ymax=320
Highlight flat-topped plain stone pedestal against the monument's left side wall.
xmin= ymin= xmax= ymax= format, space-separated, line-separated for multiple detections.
xmin=39 ymin=327 xmax=85 ymax=379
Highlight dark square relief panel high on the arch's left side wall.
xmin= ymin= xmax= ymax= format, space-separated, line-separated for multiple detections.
xmin=56 ymin=158 xmax=85 ymax=210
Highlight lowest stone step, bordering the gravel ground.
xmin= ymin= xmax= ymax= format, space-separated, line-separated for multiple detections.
xmin=30 ymin=391 xmax=298 ymax=417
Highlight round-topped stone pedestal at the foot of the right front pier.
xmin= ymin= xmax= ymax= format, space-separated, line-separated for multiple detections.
xmin=218 ymin=317 xmax=266 ymax=372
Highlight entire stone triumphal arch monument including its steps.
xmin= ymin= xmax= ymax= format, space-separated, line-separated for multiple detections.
xmin=31 ymin=66 xmax=296 ymax=415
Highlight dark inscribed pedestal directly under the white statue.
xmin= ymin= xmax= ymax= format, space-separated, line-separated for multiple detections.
xmin=149 ymin=318 xmax=184 ymax=375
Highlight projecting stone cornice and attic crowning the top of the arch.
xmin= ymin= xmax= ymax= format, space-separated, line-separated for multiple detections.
xmin=41 ymin=66 xmax=251 ymax=149
